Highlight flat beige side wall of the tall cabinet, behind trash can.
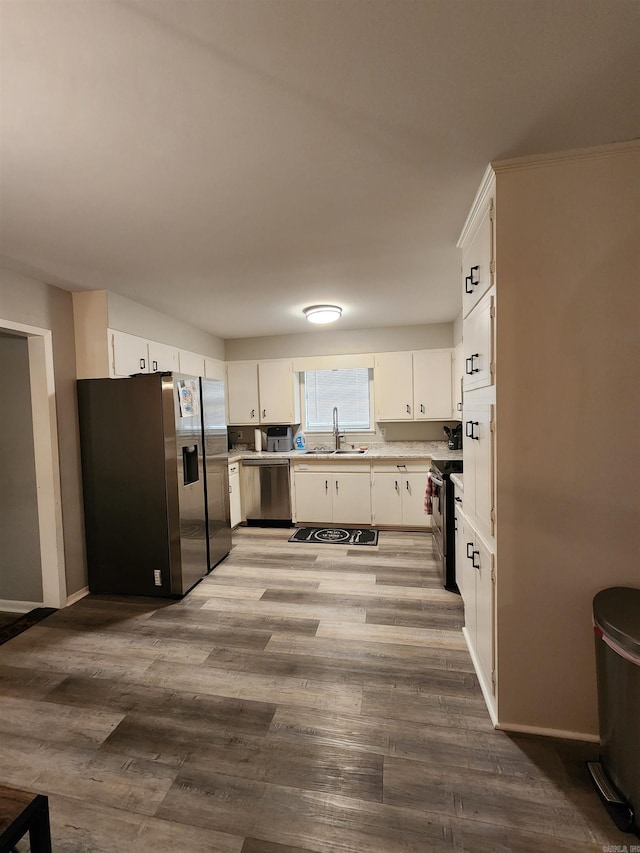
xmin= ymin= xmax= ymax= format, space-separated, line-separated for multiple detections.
xmin=496 ymin=143 xmax=640 ymax=735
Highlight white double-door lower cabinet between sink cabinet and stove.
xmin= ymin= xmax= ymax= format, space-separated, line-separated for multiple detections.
xmin=371 ymin=463 xmax=431 ymax=528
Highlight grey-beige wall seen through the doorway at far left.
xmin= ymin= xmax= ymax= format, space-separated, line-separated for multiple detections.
xmin=0 ymin=334 xmax=42 ymax=602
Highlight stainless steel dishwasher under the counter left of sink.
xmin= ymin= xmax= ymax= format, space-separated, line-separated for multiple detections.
xmin=241 ymin=457 xmax=291 ymax=527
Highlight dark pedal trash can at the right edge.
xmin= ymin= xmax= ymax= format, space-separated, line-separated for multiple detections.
xmin=589 ymin=587 xmax=640 ymax=832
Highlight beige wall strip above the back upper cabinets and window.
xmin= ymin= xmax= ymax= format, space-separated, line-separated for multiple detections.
xmin=225 ymin=323 xmax=453 ymax=361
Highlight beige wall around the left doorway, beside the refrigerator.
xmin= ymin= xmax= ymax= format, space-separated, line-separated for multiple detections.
xmin=0 ymin=270 xmax=87 ymax=595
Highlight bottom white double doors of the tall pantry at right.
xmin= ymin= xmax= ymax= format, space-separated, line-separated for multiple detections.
xmin=455 ymin=502 xmax=496 ymax=709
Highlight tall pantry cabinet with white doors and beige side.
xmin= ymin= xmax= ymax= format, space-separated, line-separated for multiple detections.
xmin=458 ymin=141 xmax=640 ymax=740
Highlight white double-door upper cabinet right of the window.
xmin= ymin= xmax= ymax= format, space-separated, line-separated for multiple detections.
xmin=373 ymin=349 xmax=453 ymax=421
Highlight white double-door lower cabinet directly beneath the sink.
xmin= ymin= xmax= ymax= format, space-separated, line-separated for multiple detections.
xmin=293 ymin=465 xmax=371 ymax=524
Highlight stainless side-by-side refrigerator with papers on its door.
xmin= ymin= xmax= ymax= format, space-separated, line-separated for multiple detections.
xmin=78 ymin=373 xmax=231 ymax=596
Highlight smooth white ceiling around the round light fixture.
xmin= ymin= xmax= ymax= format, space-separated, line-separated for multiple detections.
xmin=0 ymin=0 xmax=640 ymax=338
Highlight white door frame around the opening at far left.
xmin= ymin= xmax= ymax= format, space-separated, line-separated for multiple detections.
xmin=0 ymin=319 xmax=67 ymax=607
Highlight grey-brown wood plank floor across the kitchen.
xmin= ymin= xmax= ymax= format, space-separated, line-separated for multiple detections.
xmin=0 ymin=528 xmax=634 ymax=853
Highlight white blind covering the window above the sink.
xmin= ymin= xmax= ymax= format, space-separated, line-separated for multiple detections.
xmin=304 ymin=367 xmax=370 ymax=432
